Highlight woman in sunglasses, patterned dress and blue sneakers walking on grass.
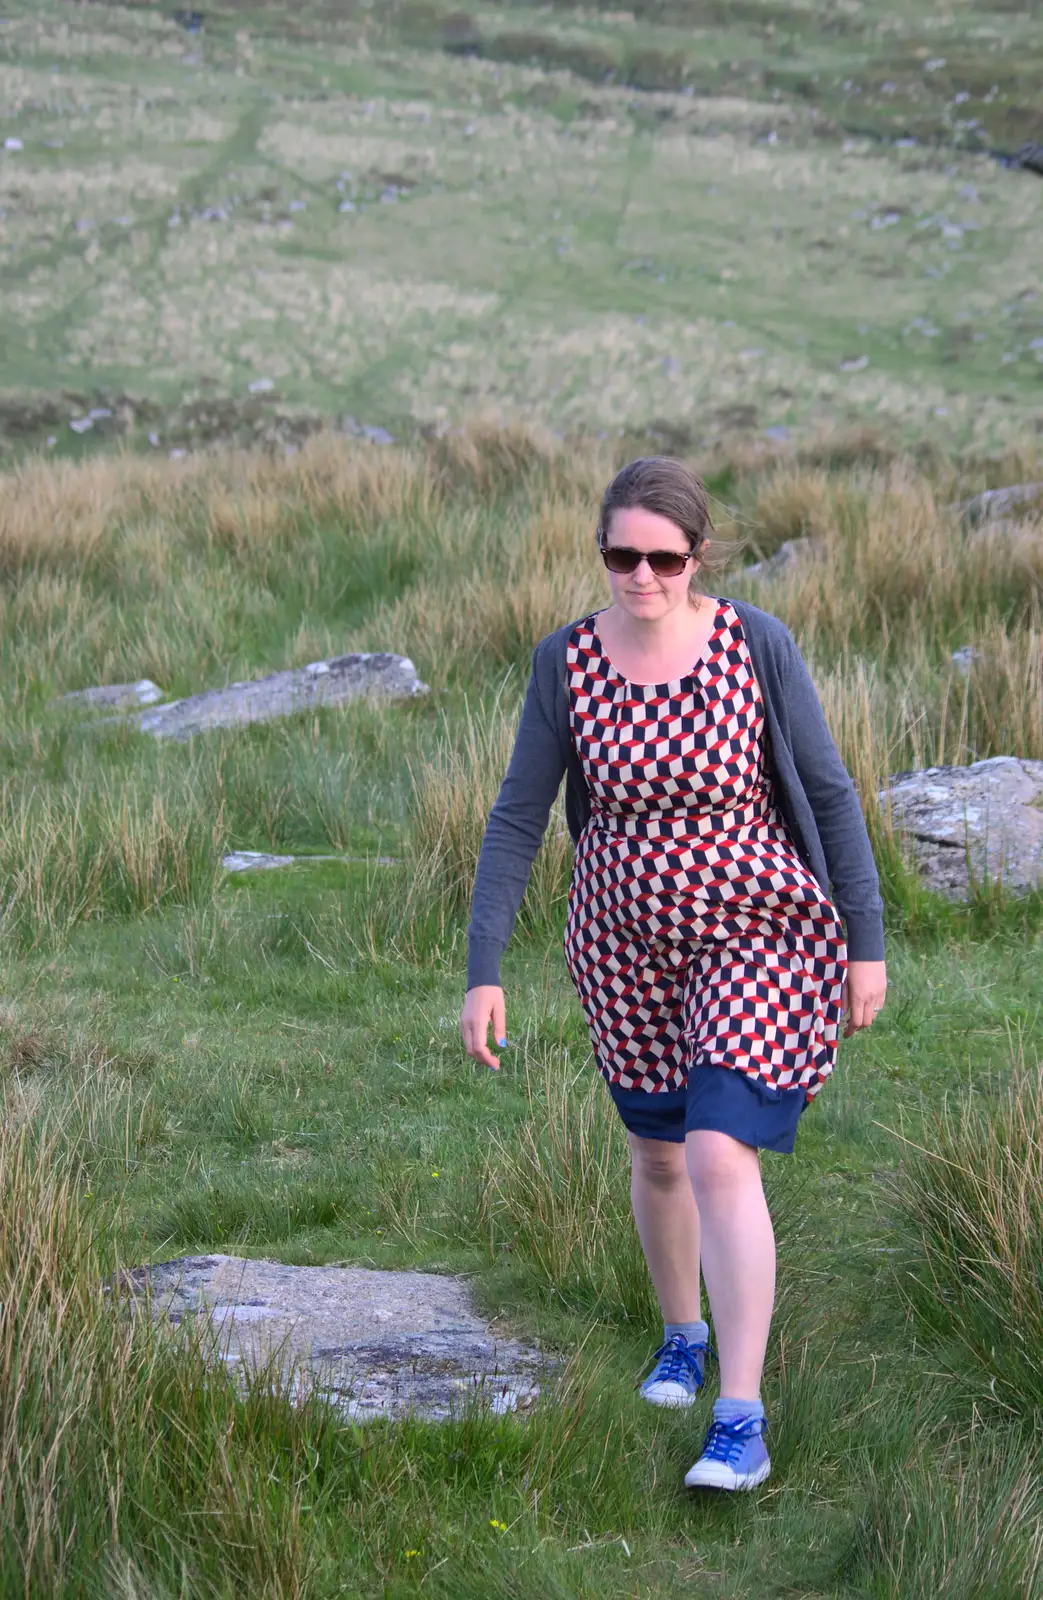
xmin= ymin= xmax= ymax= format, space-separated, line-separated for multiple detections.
xmin=461 ymin=456 xmax=886 ymax=1490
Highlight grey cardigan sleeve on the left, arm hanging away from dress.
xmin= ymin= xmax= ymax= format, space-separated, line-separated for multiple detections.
xmin=467 ymin=646 xmax=565 ymax=989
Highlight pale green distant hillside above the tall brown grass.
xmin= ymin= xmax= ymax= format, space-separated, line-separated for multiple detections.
xmin=0 ymin=0 xmax=1043 ymax=453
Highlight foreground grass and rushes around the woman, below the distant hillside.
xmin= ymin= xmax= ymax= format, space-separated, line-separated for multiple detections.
xmin=0 ymin=422 xmax=1043 ymax=1600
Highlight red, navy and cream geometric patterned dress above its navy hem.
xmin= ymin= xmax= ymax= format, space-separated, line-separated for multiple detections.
xmin=565 ymin=600 xmax=846 ymax=1099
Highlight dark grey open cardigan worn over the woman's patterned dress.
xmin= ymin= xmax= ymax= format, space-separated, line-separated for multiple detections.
xmin=467 ymin=600 xmax=883 ymax=989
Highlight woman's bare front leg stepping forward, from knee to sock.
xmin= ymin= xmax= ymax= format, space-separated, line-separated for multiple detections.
xmin=684 ymin=1128 xmax=774 ymax=1400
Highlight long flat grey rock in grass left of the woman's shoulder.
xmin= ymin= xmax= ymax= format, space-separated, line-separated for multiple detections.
xmin=121 ymin=651 xmax=429 ymax=739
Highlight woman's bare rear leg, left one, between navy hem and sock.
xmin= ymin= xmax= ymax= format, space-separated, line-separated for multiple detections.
xmin=627 ymin=1133 xmax=699 ymax=1322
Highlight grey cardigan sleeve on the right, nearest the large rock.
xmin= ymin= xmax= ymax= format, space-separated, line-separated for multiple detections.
xmin=784 ymin=630 xmax=883 ymax=962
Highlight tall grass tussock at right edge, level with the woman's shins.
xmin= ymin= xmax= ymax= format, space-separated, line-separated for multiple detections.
xmin=897 ymin=1051 xmax=1043 ymax=1418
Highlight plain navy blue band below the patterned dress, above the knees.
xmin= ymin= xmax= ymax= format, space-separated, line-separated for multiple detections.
xmin=608 ymin=1066 xmax=808 ymax=1154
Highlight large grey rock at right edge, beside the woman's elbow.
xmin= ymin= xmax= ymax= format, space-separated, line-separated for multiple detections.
xmin=880 ymin=755 xmax=1043 ymax=899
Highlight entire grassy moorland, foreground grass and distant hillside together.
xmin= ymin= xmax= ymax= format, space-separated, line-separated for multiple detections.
xmin=0 ymin=0 xmax=1043 ymax=1600
